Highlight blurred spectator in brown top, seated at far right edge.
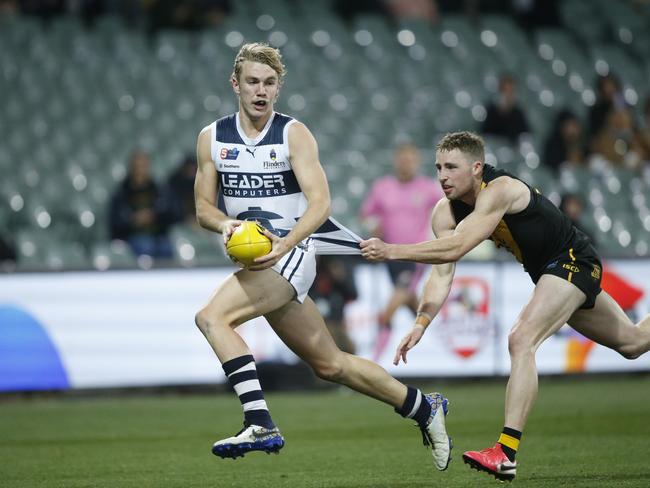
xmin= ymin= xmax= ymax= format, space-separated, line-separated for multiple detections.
xmin=591 ymin=107 xmax=644 ymax=170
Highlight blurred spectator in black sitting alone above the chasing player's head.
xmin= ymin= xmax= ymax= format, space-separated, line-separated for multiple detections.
xmin=481 ymin=74 xmax=530 ymax=143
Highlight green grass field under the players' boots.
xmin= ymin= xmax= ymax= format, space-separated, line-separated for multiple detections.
xmin=0 ymin=376 xmax=650 ymax=488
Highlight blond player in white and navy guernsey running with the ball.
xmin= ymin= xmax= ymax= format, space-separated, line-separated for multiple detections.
xmin=195 ymin=43 xmax=451 ymax=470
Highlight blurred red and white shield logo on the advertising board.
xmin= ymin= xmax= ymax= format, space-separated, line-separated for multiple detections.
xmin=437 ymin=277 xmax=494 ymax=359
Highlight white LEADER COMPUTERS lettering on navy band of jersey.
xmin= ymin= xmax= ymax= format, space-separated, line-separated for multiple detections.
xmin=220 ymin=171 xmax=300 ymax=198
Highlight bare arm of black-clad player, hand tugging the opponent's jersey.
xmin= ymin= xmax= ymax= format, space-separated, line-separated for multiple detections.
xmin=361 ymin=178 xmax=530 ymax=264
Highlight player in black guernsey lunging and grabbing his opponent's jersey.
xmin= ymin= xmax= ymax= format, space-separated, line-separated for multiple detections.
xmin=361 ymin=132 xmax=650 ymax=480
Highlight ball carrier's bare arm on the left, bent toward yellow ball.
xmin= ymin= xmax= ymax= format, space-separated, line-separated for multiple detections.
xmin=194 ymin=126 xmax=239 ymax=243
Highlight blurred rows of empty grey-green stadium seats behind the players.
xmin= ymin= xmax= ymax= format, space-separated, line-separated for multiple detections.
xmin=0 ymin=0 xmax=650 ymax=266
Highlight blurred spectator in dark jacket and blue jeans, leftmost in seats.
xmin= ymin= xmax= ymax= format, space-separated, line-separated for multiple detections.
xmin=110 ymin=151 xmax=175 ymax=258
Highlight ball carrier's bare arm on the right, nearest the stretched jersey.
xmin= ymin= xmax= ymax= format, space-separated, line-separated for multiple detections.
xmin=250 ymin=122 xmax=330 ymax=270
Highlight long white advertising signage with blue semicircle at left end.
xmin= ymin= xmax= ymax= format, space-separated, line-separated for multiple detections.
xmin=0 ymin=260 xmax=650 ymax=391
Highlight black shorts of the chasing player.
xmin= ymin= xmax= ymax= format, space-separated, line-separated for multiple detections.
xmin=533 ymin=245 xmax=603 ymax=309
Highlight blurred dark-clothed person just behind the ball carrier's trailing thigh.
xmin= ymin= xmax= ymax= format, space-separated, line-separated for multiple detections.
xmin=309 ymin=256 xmax=357 ymax=354
